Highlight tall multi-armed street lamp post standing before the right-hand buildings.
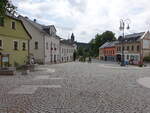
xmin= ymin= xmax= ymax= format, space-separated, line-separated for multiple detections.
xmin=119 ymin=19 xmax=130 ymax=66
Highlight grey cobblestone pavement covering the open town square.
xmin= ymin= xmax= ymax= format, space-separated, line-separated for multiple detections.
xmin=0 ymin=62 xmax=150 ymax=113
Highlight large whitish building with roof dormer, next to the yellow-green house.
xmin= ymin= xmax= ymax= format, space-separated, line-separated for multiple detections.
xmin=19 ymin=16 xmax=60 ymax=64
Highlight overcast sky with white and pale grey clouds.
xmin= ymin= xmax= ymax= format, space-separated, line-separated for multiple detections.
xmin=12 ymin=0 xmax=150 ymax=42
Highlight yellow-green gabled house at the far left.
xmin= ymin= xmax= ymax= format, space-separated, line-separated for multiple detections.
xmin=0 ymin=14 xmax=32 ymax=67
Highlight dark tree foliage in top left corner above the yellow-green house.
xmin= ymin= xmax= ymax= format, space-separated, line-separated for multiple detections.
xmin=0 ymin=0 xmax=17 ymax=16
